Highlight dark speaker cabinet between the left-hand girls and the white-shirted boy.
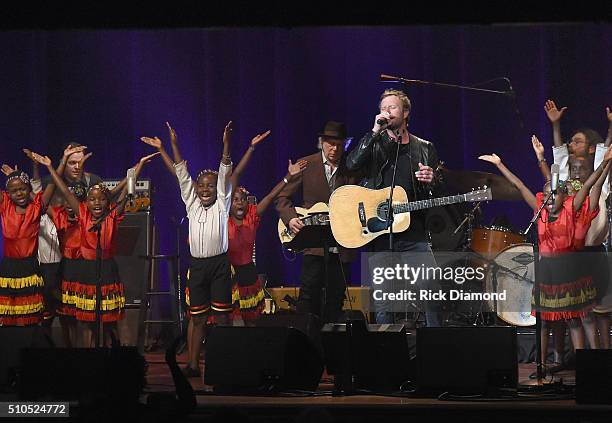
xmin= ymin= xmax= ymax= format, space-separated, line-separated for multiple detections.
xmin=115 ymin=211 xmax=155 ymax=304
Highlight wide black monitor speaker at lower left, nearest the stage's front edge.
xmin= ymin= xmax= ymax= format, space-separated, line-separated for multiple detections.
xmin=19 ymin=347 xmax=145 ymax=406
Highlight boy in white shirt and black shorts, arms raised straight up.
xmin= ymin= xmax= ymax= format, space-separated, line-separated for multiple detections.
xmin=141 ymin=121 xmax=232 ymax=377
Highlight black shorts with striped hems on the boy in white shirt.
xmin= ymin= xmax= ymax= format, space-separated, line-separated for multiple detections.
xmin=187 ymin=253 xmax=232 ymax=317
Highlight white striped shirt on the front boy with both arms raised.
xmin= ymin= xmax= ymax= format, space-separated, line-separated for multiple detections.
xmin=174 ymin=160 xmax=232 ymax=258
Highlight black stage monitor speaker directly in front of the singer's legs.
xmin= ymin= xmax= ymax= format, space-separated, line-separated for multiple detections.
xmin=321 ymin=320 xmax=414 ymax=392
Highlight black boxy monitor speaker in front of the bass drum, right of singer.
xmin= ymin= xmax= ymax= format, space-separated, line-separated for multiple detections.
xmin=416 ymin=326 xmax=518 ymax=396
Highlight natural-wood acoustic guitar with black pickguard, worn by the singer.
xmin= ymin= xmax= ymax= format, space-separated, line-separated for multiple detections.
xmin=329 ymin=185 xmax=491 ymax=248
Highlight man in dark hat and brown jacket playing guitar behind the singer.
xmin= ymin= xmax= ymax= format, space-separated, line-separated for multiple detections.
xmin=275 ymin=121 xmax=357 ymax=322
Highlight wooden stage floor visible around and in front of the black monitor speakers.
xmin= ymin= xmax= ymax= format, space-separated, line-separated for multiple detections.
xmin=140 ymin=353 xmax=612 ymax=423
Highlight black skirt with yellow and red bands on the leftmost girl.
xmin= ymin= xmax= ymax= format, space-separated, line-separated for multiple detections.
xmin=0 ymin=257 xmax=45 ymax=326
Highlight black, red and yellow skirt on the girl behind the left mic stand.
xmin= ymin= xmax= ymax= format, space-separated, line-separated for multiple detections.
xmin=58 ymin=258 xmax=125 ymax=322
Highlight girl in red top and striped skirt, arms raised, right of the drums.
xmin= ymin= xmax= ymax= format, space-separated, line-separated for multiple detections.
xmin=479 ymin=143 xmax=612 ymax=372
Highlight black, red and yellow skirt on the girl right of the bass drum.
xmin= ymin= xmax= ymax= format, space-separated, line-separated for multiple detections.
xmin=532 ymin=252 xmax=597 ymax=320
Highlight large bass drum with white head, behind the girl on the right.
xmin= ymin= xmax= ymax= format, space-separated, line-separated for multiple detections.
xmin=486 ymin=243 xmax=535 ymax=326
